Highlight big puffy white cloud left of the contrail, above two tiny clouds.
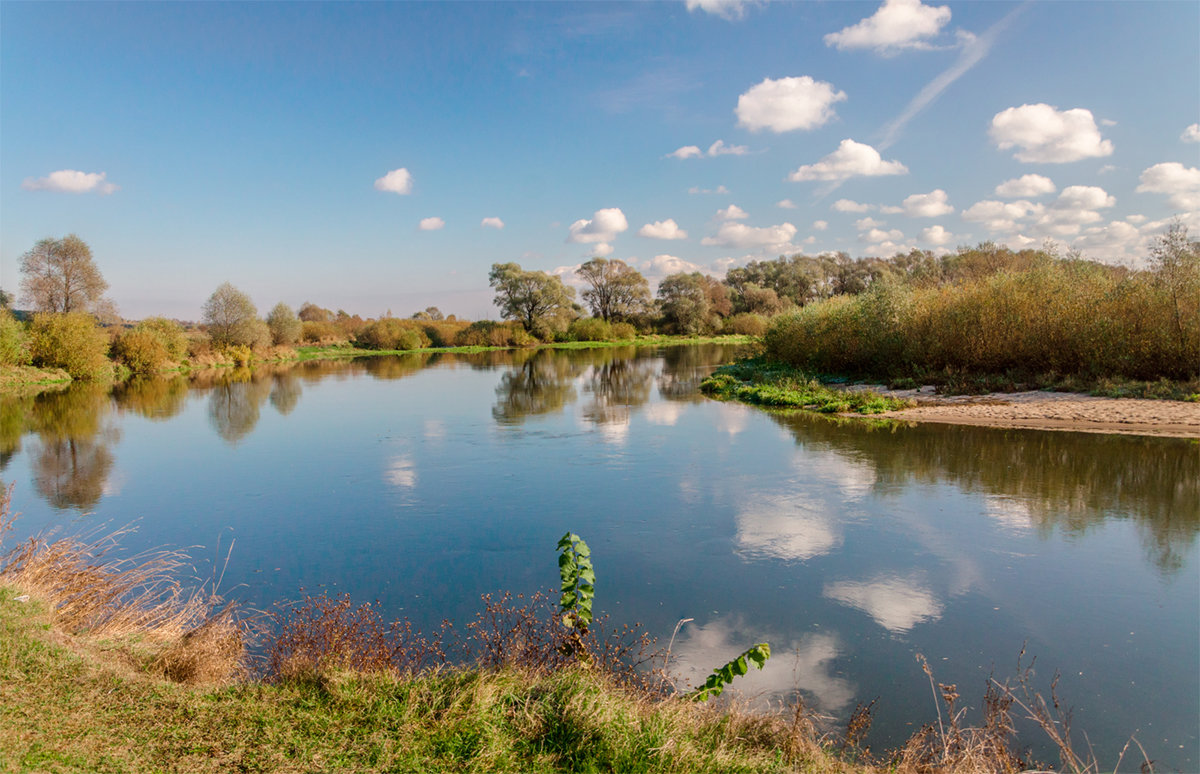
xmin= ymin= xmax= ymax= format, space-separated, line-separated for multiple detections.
xmin=734 ymin=76 xmax=846 ymax=132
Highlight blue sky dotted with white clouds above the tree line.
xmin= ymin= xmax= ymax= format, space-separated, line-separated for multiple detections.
xmin=0 ymin=0 xmax=1200 ymax=319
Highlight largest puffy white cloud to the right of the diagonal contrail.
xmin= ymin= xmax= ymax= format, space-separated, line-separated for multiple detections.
xmin=989 ymin=103 xmax=1112 ymax=164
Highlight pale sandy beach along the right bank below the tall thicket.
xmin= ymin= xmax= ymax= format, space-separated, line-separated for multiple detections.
xmin=849 ymin=386 xmax=1200 ymax=438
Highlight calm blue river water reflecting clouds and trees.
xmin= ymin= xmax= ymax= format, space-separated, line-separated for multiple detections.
xmin=0 ymin=346 xmax=1200 ymax=770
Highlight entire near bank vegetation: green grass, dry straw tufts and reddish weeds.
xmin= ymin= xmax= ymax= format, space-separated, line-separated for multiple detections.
xmin=0 ymin=493 xmax=1128 ymax=774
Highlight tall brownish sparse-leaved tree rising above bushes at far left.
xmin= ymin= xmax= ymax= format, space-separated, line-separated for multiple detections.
xmin=20 ymin=234 xmax=108 ymax=313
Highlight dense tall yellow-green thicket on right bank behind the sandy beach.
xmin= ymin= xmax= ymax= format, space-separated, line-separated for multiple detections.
xmin=764 ymin=245 xmax=1200 ymax=379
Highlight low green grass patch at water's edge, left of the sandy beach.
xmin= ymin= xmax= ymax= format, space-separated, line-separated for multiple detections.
xmin=700 ymin=358 xmax=912 ymax=414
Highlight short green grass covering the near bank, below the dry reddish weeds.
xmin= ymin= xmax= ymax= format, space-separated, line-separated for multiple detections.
xmin=0 ymin=588 xmax=869 ymax=772
